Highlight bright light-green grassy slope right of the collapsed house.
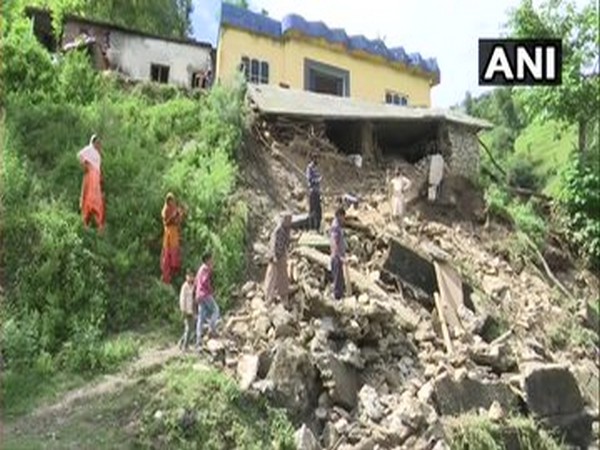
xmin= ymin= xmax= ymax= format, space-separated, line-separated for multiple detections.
xmin=515 ymin=122 xmax=577 ymax=196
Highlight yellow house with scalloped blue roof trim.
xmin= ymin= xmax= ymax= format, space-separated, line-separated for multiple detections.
xmin=216 ymin=2 xmax=440 ymax=107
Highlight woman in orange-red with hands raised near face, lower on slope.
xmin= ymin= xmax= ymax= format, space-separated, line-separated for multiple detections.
xmin=160 ymin=193 xmax=185 ymax=284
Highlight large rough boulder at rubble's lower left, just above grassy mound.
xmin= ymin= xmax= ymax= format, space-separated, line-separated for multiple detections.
xmin=266 ymin=341 xmax=318 ymax=419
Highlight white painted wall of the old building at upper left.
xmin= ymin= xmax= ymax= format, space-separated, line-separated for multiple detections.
xmin=107 ymin=30 xmax=211 ymax=87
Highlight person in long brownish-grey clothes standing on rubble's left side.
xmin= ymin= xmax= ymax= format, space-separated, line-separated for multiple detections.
xmin=264 ymin=212 xmax=292 ymax=304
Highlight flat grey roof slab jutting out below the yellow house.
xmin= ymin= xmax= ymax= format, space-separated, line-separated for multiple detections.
xmin=248 ymin=85 xmax=493 ymax=131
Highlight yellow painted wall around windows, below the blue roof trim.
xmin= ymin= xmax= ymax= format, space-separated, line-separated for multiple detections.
xmin=216 ymin=26 xmax=431 ymax=107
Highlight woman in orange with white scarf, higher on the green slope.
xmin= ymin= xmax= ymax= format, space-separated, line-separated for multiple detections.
xmin=78 ymin=134 xmax=104 ymax=231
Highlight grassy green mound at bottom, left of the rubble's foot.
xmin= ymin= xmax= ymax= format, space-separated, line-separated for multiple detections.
xmin=140 ymin=361 xmax=295 ymax=450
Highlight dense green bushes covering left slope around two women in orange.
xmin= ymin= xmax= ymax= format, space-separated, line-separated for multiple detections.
xmin=0 ymin=3 xmax=247 ymax=413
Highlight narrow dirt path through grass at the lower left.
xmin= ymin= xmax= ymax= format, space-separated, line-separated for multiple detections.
xmin=4 ymin=346 xmax=182 ymax=434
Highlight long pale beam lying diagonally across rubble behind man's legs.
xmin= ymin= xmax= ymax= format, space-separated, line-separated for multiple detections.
xmin=295 ymin=247 xmax=420 ymax=330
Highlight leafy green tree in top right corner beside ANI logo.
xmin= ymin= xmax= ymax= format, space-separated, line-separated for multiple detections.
xmin=508 ymin=0 xmax=600 ymax=155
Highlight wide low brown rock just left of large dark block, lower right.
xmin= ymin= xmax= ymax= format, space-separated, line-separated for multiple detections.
xmin=433 ymin=374 xmax=518 ymax=415
